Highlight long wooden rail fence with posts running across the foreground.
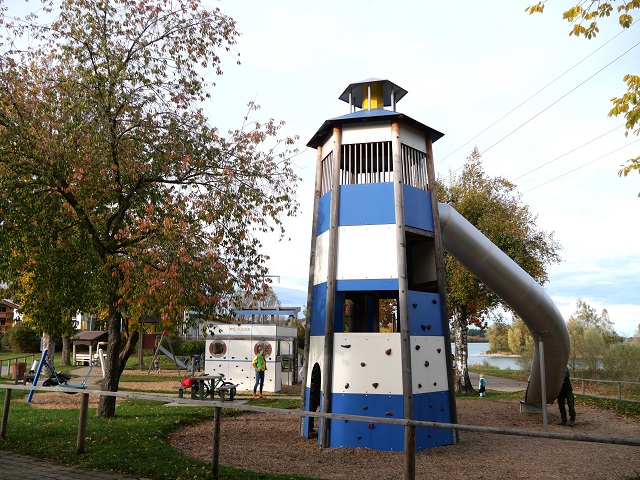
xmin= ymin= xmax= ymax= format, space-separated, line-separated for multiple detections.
xmin=0 ymin=384 xmax=640 ymax=480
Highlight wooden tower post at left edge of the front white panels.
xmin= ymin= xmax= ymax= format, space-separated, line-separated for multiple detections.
xmin=320 ymin=127 xmax=342 ymax=448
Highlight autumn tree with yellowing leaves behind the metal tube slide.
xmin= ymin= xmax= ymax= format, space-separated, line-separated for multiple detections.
xmin=438 ymin=149 xmax=559 ymax=393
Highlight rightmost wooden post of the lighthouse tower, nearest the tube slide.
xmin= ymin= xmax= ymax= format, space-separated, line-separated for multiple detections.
xmin=425 ymin=132 xmax=459 ymax=436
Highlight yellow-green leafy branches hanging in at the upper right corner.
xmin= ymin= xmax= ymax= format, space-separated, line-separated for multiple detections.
xmin=526 ymin=0 xmax=640 ymax=186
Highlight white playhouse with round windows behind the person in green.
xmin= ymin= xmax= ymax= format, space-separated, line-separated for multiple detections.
xmin=204 ymin=324 xmax=298 ymax=392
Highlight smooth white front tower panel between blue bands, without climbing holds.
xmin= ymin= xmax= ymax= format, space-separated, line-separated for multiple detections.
xmin=338 ymin=225 xmax=398 ymax=280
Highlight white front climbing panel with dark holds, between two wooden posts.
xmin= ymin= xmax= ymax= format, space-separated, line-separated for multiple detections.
xmin=333 ymin=333 xmax=402 ymax=395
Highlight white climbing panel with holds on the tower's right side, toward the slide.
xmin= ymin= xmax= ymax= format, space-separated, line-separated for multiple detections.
xmin=412 ymin=337 xmax=451 ymax=394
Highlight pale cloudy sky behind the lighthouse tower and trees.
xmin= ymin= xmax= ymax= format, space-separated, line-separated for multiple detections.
xmin=205 ymin=0 xmax=640 ymax=336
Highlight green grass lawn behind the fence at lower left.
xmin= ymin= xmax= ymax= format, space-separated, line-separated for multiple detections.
xmin=0 ymin=390 xmax=318 ymax=480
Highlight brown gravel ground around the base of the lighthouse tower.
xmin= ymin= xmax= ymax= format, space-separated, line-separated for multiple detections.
xmin=170 ymin=398 xmax=640 ymax=480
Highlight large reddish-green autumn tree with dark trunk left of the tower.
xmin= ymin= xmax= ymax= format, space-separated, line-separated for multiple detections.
xmin=0 ymin=0 xmax=297 ymax=416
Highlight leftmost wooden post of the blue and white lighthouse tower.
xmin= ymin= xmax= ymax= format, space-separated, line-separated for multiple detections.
xmin=294 ymin=147 xmax=322 ymax=437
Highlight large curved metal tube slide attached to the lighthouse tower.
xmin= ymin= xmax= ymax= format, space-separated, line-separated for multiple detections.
xmin=438 ymin=203 xmax=569 ymax=407
